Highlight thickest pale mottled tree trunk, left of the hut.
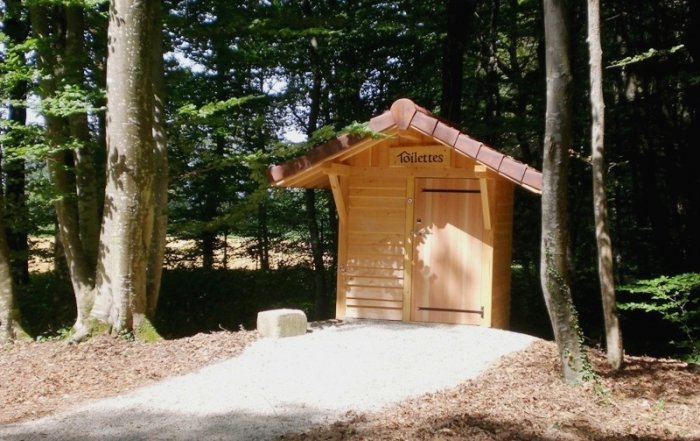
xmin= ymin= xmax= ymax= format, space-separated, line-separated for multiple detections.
xmin=92 ymin=0 xmax=158 ymax=333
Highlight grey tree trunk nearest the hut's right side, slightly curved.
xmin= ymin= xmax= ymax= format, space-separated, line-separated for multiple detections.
xmin=540 ymin=0 xmax=591 ymax=384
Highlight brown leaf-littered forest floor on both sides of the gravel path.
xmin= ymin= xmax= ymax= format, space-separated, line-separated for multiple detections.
xmin=0 ymin=324 xmax=700 ymax=440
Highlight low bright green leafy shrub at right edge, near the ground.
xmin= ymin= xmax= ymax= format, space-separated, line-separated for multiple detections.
xmin=618 ymin=273 xmax=700 ymax=363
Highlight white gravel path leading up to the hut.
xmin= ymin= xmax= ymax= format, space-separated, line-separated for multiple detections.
xmin=0 ymin=320 xmax=535 ymax=441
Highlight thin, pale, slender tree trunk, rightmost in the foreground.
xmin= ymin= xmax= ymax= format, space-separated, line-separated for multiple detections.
xmin=588 ymin=0 xmax=624 ymax=370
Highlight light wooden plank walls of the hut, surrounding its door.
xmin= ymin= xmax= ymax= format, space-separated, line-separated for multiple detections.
xmin=332 ymin=139 xmax=514 ymax=328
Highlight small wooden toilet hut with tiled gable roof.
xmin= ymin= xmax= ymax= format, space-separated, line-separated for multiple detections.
xmin=268 ymin=99 xmax=542 ymax=328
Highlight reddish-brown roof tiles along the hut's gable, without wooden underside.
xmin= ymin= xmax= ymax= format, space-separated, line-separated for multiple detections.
xmin=268 ymin=98 xmax=542 ymax=193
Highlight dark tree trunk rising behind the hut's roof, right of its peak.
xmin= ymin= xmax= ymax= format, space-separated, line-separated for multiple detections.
xmin=440 ymin=0 xmax=477 ymax=124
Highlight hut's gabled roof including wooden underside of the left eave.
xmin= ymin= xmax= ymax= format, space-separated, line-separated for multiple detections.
xmin=268 ymin=98 xmax=542 ymax=193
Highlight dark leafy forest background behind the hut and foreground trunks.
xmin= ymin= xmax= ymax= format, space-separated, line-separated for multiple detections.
xmin=0 ymin=0 xmax=700 ymax=354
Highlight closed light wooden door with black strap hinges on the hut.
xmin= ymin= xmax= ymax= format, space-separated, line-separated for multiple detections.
xmin=411 ymin=178 xmax=483 ymax=324
